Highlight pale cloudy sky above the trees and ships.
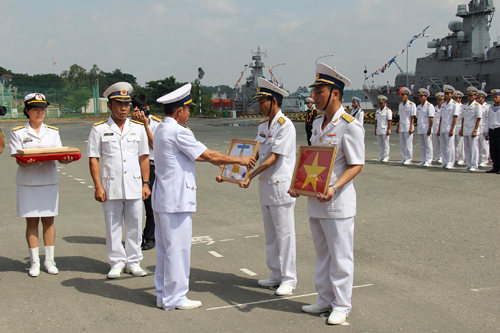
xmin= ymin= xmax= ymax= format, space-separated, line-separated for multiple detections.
xmin=0 ymin=0 xmax=500 ymax=91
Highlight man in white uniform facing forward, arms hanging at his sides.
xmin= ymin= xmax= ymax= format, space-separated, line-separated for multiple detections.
xmin=87 ymin=82 xmax=151 ymax=279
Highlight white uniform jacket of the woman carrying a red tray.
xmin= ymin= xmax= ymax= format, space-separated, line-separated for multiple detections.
xmin=9 ymin=122 xmax=62 ymax=185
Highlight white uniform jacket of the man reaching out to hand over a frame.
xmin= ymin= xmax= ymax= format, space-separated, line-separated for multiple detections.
xmin=153 ymin=117 xmax=207 ymax=213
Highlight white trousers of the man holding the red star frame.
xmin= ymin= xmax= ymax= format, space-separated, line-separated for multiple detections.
xmin=309 ymin=217 xmax=354 ymax=314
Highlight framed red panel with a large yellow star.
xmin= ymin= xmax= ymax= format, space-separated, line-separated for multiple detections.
xmin=290 ymin=146 xmax=338 ymax=197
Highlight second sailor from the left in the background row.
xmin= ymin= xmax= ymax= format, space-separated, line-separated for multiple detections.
xmin=396 ymin=87 xmax=417 ymax=165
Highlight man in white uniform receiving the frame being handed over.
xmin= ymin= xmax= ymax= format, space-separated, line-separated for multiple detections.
xmin=240 ymin=77 xmax=297 ymax=296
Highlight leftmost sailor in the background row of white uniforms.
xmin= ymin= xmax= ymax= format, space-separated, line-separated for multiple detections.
xmin=375 ymin=95 xmax=392 ymax=162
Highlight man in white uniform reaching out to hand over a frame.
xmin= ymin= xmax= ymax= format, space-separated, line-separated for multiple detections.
xmin=153 ymin=84 xmax=255 ymax=310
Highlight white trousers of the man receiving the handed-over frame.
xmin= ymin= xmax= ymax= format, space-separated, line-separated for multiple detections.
xmin=261 ymin=201 xmax=297 ymax=287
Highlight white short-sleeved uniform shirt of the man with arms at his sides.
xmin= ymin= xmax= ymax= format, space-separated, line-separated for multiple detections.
xmin=87 ymin=117 xmax=149 ymax=200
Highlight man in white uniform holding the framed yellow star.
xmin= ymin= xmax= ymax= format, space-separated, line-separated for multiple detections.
xmin=289 ymin=64 xmax=365 ymax=325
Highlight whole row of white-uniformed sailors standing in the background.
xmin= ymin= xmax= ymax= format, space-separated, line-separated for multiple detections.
xmin=375 ymin=85 xmax=500 ymax=173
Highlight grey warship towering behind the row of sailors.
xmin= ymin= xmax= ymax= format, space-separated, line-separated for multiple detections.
xmin=363 ymin=0 xmax=500 ymax=110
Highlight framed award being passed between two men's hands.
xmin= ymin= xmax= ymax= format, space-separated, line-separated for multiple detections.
xmin=219 ymin=139 xmax=260 ymax=184
